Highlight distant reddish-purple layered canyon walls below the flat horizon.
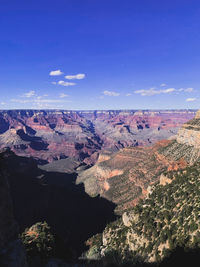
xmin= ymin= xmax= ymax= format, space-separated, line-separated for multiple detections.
xmin=0 ymin=110 xmax=195 ymax=165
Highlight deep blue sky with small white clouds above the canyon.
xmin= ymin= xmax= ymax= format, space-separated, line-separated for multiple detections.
xmin=0 ymin=0 xmax=200 ymax=110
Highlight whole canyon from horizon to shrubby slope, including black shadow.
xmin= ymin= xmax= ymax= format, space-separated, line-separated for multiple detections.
xmin=0 ymin=110 xmax=200 ymax=266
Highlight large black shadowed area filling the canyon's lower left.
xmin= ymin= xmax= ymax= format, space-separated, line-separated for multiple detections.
xmin=0 ymin=151 xmax=116 ymax=267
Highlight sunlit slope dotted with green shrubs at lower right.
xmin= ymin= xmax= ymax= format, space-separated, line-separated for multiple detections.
xmin=87 ymin=163 xmax=200 ymax=262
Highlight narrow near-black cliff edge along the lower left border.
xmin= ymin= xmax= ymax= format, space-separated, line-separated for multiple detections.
xmin=0 ymin=154 xmax=27 ymax=267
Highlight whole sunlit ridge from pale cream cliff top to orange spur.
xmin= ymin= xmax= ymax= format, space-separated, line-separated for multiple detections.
xmin=77 ymin=113 xmax=200 ymax=214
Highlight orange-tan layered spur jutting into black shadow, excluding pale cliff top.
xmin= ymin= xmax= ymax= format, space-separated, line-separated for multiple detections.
xmin=77 ymin=140 xmax=187 ymax=214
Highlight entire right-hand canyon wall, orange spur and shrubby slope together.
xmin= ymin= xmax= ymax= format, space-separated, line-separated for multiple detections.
xmin=85 ymin=111 xmax=200 ymax=266
